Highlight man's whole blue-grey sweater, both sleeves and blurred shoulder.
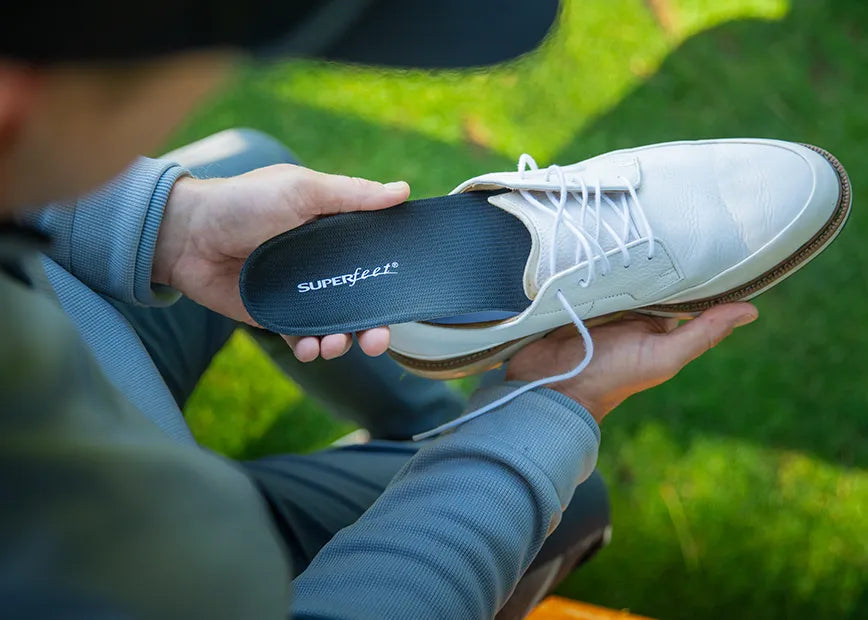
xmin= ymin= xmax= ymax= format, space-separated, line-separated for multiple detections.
xmin=0 ymin=159 xmax=599 ymax=619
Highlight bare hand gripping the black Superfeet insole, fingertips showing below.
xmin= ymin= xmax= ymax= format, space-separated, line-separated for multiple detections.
xmin=152 ymin=164 xmax=410 ymax=362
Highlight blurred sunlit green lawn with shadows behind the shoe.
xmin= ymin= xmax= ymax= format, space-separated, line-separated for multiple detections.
xmin=166 ymin=0 xmax=868 ymax=619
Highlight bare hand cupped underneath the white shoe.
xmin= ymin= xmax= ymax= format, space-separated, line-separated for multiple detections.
xmin=506 ymin=303 xmax=757 ymax=422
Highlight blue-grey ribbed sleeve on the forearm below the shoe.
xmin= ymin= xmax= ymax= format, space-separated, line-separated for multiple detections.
xmin=292 ymin=383 xmax=600 ymax=619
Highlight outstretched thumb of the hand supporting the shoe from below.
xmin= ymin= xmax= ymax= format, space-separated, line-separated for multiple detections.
xmin=658 ymin=303 xmax=759 ymax=374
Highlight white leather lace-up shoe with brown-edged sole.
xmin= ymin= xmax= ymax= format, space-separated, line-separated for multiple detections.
xmin=390 ymin=139 xmax=851 ymax=378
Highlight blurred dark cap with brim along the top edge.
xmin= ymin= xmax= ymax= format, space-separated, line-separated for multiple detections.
xmin=0 ymin=0 xmax=558 ymax=68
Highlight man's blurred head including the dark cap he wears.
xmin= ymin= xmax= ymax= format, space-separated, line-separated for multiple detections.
xmin=0 ymin=0 xmax=558 ymax=216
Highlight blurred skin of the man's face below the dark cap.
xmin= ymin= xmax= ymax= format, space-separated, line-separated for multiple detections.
xmin=0 ymin=51 xmax=233 ymax=212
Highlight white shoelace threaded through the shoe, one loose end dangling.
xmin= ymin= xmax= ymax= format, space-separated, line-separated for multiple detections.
xmin=413 ymin=154 xmax=654 ymax=441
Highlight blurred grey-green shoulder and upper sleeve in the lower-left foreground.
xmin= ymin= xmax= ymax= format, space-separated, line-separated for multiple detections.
xmin=0 ymin=253 xmax=289 ymax=620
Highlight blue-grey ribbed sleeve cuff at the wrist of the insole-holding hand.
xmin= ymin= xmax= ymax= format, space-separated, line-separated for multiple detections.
xmin=23 ymin=157 xmax=187 ymax=306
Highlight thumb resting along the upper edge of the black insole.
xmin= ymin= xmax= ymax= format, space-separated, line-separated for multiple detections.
xmin=298 ymin=169 xmax=410 ymax=217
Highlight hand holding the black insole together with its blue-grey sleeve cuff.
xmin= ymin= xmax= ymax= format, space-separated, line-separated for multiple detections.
xmin=21 ymin=157 xmax=410 ymax=361
